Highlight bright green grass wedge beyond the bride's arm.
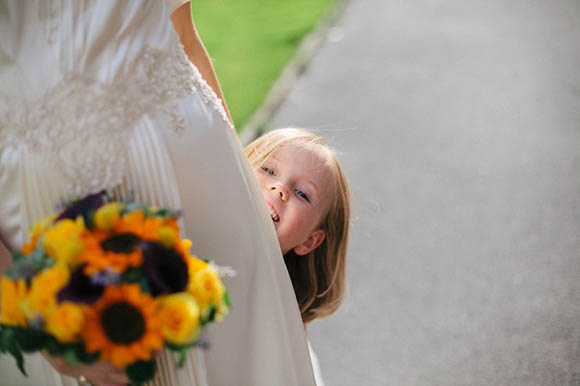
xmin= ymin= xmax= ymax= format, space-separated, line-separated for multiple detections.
xmin=191 ymin=0 xmax=336 ymax=130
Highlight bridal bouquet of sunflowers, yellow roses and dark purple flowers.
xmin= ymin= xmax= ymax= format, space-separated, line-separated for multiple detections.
xmin=0 ymin=193 xmax=230 ymax=384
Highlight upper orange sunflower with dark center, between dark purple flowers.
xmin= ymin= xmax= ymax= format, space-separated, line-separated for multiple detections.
xmin=79 ymin=231 xmax=143 ymax=275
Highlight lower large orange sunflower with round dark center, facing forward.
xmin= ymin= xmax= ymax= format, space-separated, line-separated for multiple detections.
xmin=83 ymin=284 xmax=163 ymax=367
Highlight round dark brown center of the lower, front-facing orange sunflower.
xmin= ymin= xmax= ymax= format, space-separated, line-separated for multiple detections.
xmin=101 ymin=302 xmax=145 ymax=345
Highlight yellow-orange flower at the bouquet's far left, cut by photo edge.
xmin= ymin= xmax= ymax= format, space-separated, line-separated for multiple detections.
xmin=0 ymin=276 xmax=28 ymax=327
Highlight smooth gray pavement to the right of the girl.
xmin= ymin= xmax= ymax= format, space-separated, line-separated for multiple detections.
xmin=270 ymin=0 xmax=580 ymax=386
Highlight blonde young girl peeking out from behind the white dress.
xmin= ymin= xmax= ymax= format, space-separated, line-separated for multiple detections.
xmin=245 ymin=129 xmax=350 ymax=325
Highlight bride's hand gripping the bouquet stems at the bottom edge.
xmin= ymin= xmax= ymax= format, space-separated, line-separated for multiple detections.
xmin=43 ymin=353 xmax=129 ymax=386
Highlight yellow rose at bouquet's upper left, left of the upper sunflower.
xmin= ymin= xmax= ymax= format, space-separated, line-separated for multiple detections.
xmin=42 ymin=217 xmax=85 ymax=267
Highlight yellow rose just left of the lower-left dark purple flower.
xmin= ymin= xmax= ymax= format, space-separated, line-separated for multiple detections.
xmin=26 ymin=263 xmax=70 ymax=317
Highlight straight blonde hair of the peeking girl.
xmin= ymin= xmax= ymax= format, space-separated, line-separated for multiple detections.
xmin=245 ymin=128 xmax=350 ymax=323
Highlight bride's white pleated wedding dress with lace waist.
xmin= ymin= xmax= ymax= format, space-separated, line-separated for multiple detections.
xmin=0 ymin=0 xmax=315 ymax=386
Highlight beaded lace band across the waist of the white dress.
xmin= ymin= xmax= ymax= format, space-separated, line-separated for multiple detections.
xmin=0 ymin=42 xmax=229 ymax=195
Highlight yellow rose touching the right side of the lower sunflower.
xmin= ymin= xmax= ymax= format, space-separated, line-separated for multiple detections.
xmin=157 ymin=292 xmax=199 ymax=345
